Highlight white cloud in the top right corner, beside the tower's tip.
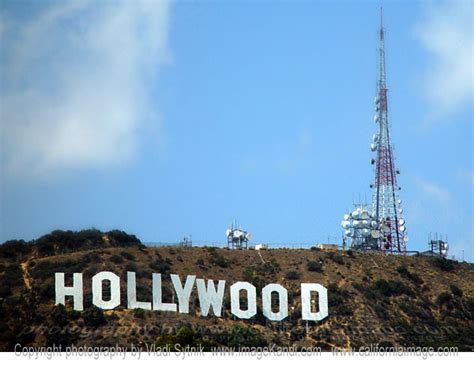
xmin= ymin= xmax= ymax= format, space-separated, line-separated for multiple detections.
xmin=416 ymin=0 xmax=474 ymax=123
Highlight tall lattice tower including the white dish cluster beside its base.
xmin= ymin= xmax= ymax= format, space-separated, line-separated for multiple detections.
xmin=341 ymin=10 xmax=408 ymax=253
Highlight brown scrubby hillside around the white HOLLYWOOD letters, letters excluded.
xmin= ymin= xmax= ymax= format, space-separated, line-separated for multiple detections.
xmin=0 ymin=230 xmax=474 ymax=351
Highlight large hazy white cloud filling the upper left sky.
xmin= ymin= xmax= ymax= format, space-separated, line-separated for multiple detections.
xmin=0 ymin=0 xmax=170 ymax=177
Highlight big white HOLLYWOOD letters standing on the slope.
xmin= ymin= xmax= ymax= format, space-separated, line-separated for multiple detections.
xmin=55 ymin=271 xmax=328 ymax=321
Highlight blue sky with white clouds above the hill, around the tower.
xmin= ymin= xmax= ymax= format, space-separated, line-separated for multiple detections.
xmin=0 ymin=1 xmax=474 ymax=261
